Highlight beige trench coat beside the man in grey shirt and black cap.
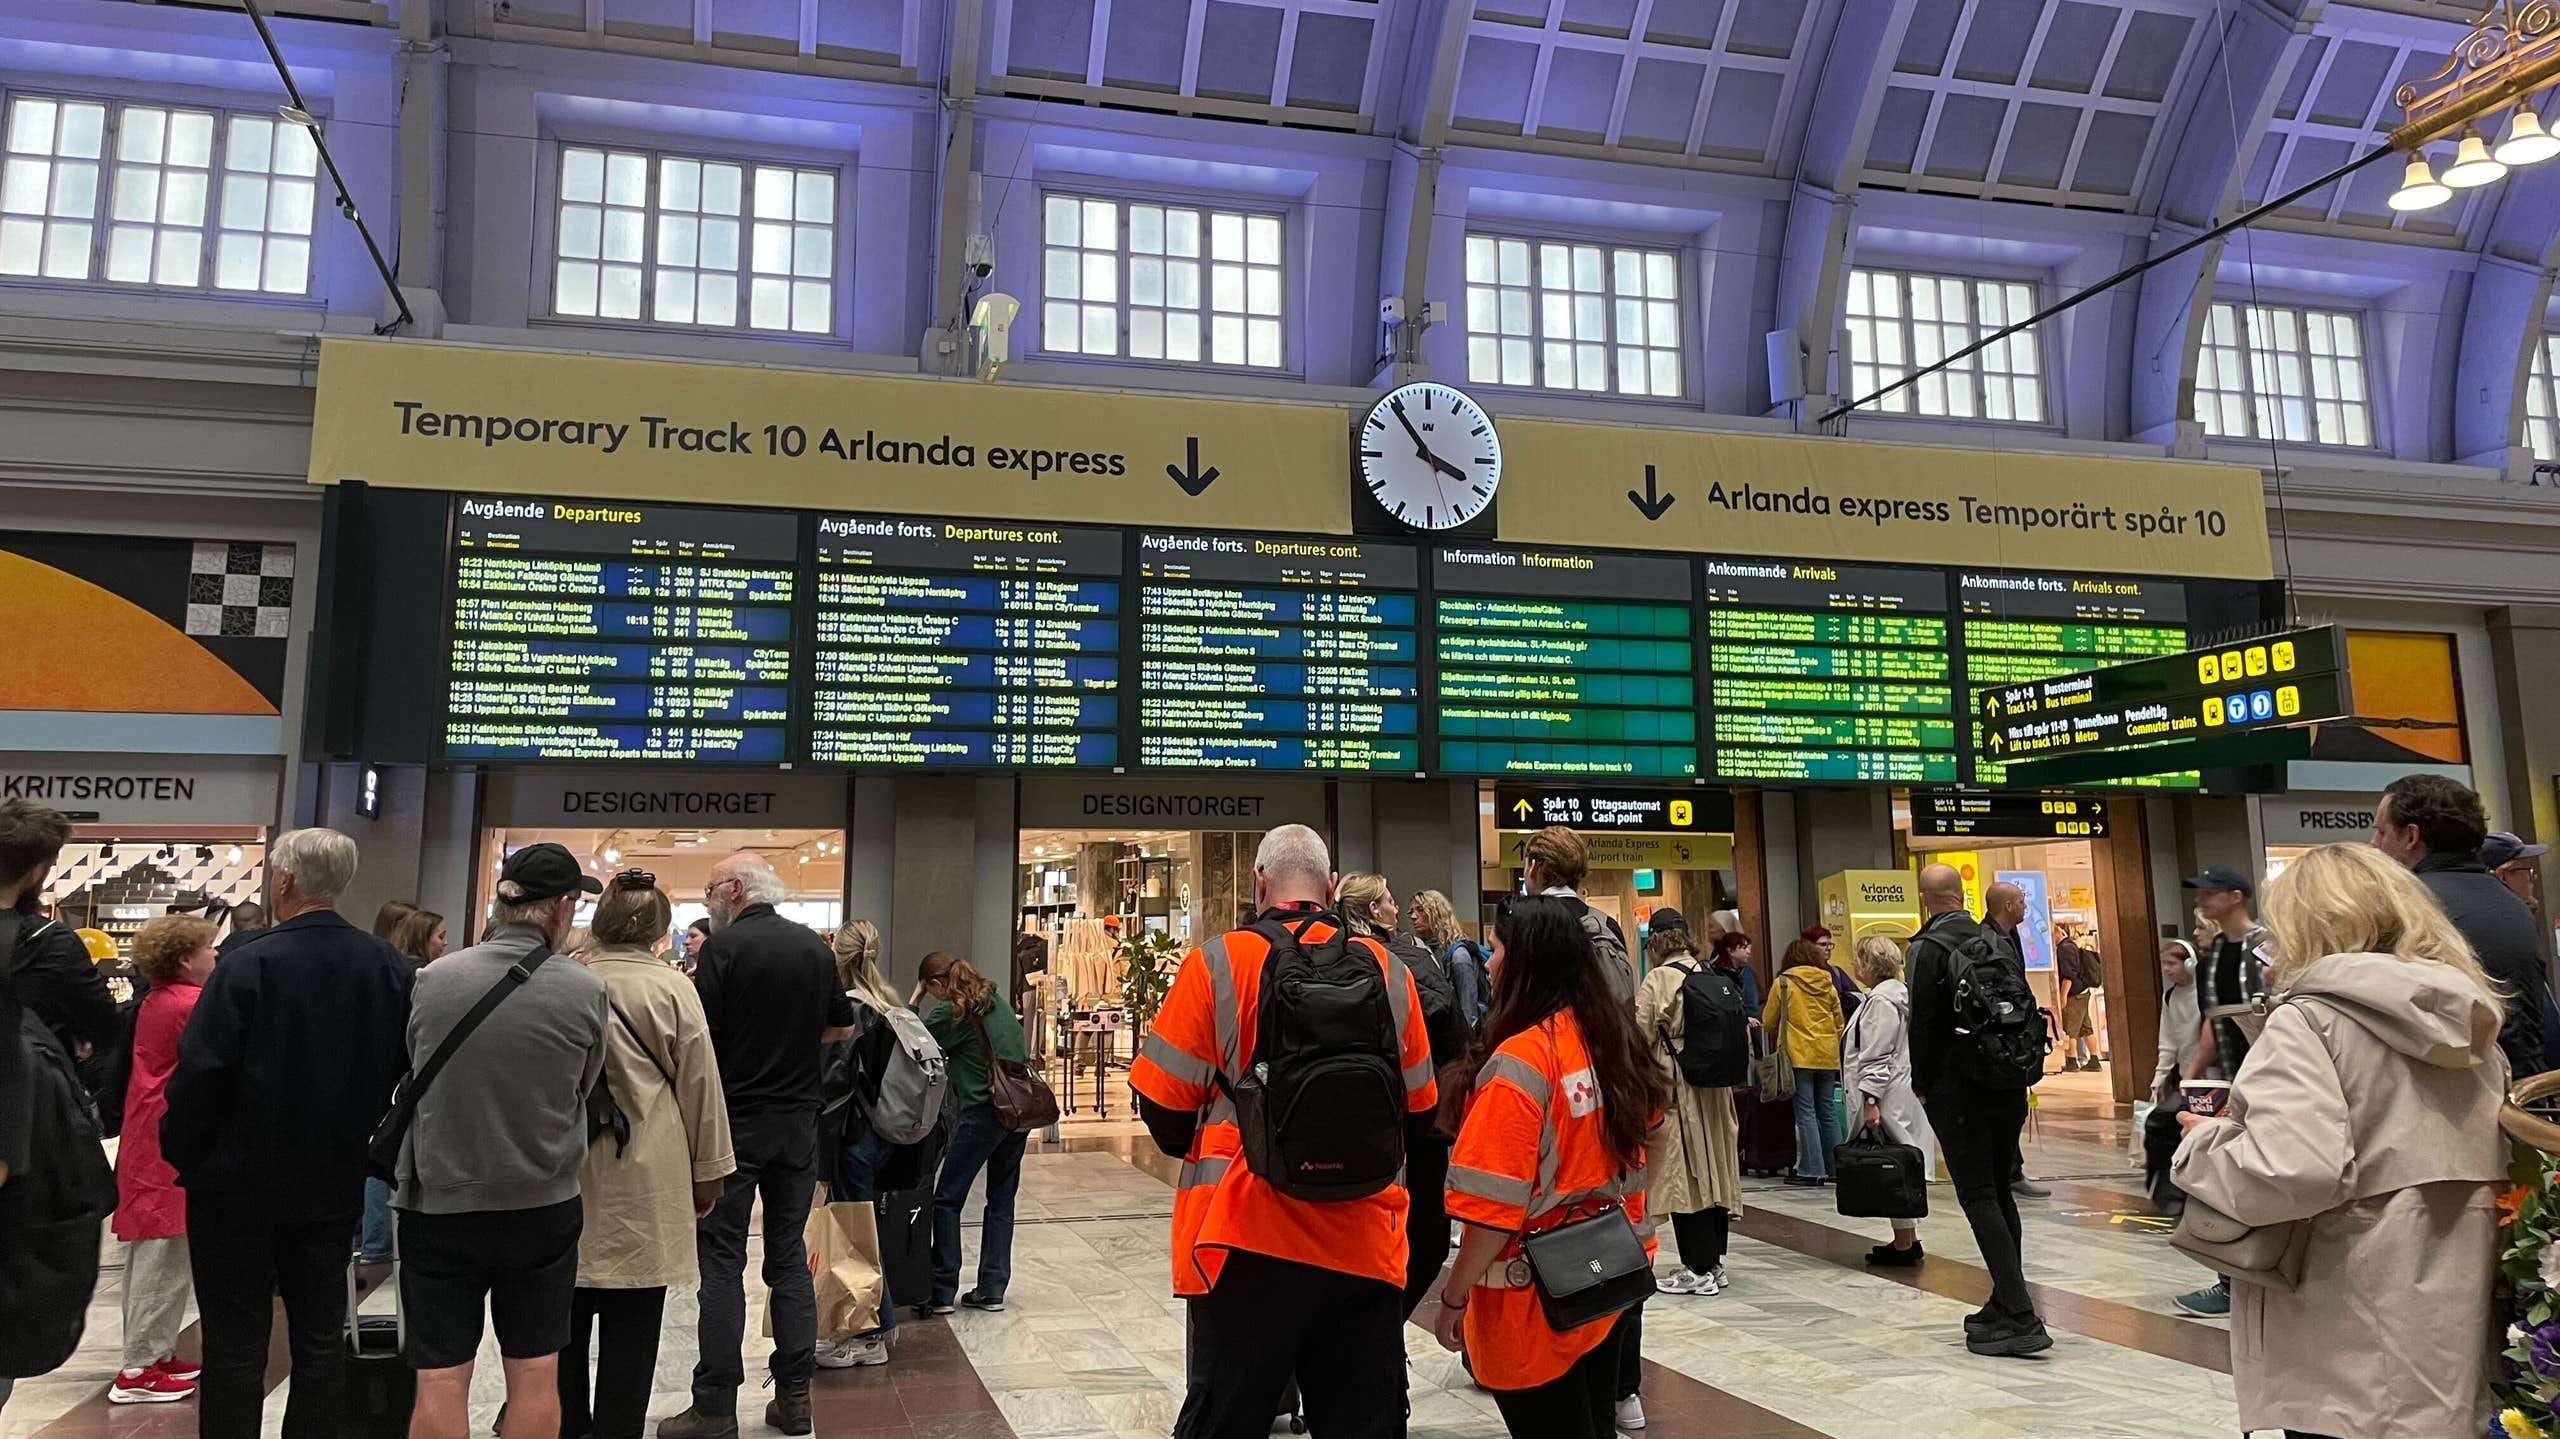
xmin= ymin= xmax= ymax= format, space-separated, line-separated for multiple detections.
xmin=579 ymin=947 xmax=737 ymax=1288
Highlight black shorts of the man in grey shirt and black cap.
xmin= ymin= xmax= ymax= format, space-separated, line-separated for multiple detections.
xmin=399 ymin=1198 xmax=586 ymax=1370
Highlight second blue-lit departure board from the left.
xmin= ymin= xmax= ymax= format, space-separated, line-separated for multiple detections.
xmin=809 ymin=515 xmax=1121 ymax=768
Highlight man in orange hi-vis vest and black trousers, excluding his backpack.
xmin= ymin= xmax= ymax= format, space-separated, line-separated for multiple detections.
xmin=1129 ymin=824 xmax=1439 ymax=1439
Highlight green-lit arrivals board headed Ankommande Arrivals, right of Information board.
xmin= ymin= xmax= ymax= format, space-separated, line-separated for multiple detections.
xmin=1705 ymin=561 xmax=1958 ymax=784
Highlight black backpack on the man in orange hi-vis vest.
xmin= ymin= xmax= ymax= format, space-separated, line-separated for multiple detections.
xmin=1219 ymin=914 xmax=1405 ymax=1203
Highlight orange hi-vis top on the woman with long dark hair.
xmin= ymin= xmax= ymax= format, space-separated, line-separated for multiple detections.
xmin=1449 ymin=1011 xmax=1654 ymax=1390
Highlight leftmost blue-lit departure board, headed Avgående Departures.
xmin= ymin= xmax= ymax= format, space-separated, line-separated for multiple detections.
xmin=443 ymin=497 xmax=799 ymax=763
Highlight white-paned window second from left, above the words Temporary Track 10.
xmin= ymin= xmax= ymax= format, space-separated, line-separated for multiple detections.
xmin=550 ymin=146 xmax=835 ymax=335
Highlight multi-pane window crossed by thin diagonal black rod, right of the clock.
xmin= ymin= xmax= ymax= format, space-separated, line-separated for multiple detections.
xmin=1846 ymin=269 xmax=2045 ymax=425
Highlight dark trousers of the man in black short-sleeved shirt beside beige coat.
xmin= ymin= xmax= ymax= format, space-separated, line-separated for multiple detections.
xmin=694 ymin=1109 xmax=817 ymax=1416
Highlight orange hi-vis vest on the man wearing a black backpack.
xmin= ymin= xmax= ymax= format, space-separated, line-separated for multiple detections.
xmin=1129 ymin=912 xmax=1439 ymax=1296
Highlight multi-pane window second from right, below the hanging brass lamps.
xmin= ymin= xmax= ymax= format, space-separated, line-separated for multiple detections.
xmin=2196 ymin=300 xmax=2373 ymax=448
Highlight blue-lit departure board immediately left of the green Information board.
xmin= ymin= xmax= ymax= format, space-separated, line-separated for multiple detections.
xmin=1137 ymin=530 xmax=1421 ymax=773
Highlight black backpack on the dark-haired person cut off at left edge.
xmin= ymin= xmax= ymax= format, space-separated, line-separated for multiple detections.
xmin=0 ymin=914 xmax=115 ymax=1380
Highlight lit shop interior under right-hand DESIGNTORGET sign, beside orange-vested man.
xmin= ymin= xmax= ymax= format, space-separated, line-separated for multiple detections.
xmin=1011 ymin=830 xmax=1262 ymax=1132
